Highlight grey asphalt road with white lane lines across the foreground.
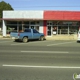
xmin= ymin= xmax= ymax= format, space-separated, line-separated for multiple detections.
xmin=0 ymin=39 xmax=80 ymax=80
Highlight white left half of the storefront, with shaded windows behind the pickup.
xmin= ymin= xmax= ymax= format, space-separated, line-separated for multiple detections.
xmin=3 ymin=11 xmax=43 ymax=36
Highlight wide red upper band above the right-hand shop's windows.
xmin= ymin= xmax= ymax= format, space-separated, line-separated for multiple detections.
xmin=44 ymin=11 xmax=80 ymax=21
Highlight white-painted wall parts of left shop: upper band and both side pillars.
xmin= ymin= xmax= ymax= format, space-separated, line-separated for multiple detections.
xmin=3 ymin=10 xmax=44 ymax=36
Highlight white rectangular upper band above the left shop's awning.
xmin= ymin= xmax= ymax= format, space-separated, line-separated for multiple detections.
xmin=3 ymin=11 xmax=43 ymax=19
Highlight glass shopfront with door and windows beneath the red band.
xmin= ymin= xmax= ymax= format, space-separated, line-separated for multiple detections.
xmin=47 ymin=21 xmax=80 ymax=35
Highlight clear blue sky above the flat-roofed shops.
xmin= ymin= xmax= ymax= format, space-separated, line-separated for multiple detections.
xmin=0 ymin=0 xmax=80 ymax=11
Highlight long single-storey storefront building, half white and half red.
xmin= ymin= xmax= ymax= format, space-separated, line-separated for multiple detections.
xmin=3 ymin=11 xmax=80 ymax=36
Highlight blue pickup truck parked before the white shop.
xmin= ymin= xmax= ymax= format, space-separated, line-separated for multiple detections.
xmin=10 ymin=29 xmax=45 ymax=43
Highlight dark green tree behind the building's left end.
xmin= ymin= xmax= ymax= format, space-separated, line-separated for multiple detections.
xmin=0 ymin=1 xmax=13 ymax=18
